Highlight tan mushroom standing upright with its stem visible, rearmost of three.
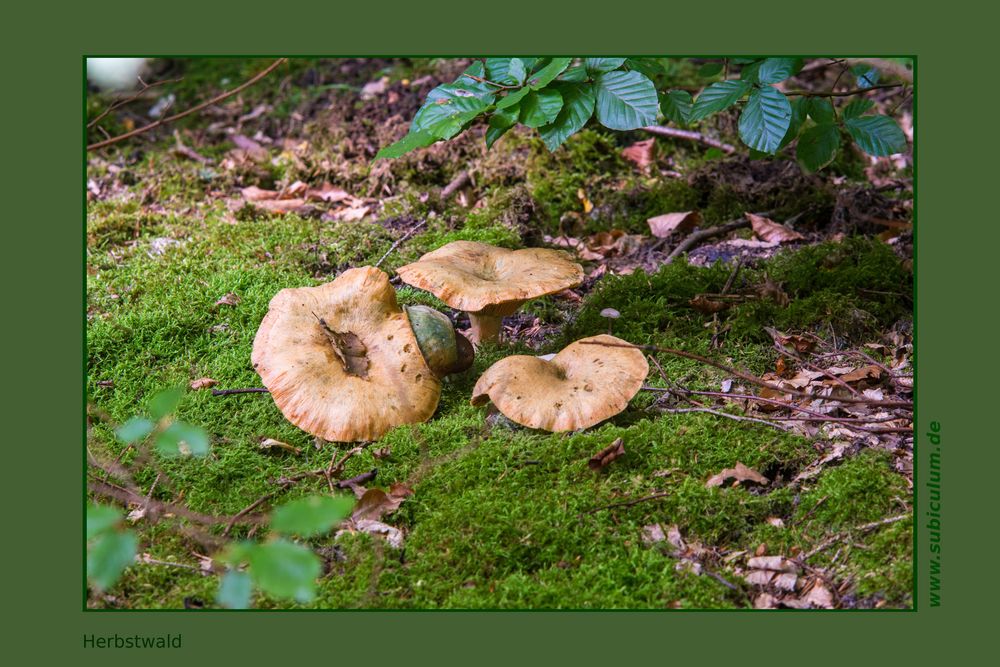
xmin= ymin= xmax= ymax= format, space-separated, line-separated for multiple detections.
xmin=396 ymin=241 xmax=583 ymax=345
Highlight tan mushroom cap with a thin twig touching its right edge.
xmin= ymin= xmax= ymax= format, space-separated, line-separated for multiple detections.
xmin=472 ymin=335 xmax=649 ymax=431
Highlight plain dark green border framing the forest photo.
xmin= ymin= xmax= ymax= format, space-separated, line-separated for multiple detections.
xmin=7 ymin=0 xmax=998 ymax=666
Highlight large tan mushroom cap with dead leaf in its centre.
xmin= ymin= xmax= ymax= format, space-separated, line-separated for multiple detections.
xmin=251 ymin=266 xmax=441 ymax=442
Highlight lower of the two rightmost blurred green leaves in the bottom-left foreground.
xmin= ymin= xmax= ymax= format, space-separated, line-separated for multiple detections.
xmin=247 ymin=539 xmax=322 ymax=602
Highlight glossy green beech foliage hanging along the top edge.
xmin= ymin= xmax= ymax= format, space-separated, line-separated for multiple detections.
xmin=376 ymin=57 xmax=906 ymax=172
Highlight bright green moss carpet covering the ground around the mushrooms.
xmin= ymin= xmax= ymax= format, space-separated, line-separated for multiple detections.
xmin=87 ymin=57 xmax=912 ymax=609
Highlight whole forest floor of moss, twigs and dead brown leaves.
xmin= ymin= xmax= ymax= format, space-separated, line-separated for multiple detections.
xmin=86 ymin=60 xmax=914 ymax=609
